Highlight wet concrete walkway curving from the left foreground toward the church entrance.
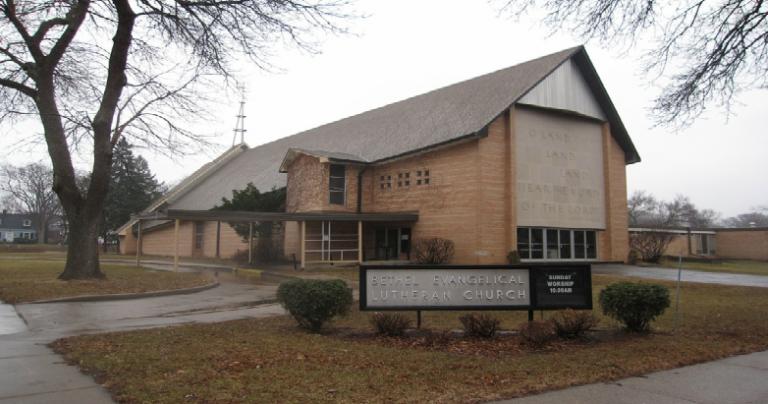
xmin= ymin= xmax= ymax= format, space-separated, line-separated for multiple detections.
xmin=0 ymin=268 xmax=284 ymax=404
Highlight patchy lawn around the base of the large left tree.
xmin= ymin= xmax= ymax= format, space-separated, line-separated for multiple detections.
xmin=0 ymin=253 xmax=211 ymax=304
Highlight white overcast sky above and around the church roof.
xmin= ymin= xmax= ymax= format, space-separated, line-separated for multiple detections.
xmin=0 ymin=0 xmax=768 ymax=217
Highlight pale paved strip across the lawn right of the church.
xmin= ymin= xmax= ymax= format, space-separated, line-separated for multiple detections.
xmin=592 ymin=264 xmax=768 ymax=288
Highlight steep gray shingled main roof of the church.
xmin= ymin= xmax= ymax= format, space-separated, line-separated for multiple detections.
xmin=169 ymin=47 xmax=639 ymax=210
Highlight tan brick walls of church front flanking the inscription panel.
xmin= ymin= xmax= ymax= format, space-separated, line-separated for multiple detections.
xmin=286 ymin=105 xmax=628 ymax=264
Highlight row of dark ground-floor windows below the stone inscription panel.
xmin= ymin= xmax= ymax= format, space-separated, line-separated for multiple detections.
xmin=517 ymin=227 xmax=597 ymax=260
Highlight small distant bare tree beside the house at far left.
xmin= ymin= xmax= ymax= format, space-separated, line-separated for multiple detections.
xmin=0 ymin=163 xmax=61 ymax=243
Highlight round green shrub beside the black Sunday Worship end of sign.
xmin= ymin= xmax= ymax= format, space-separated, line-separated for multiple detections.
xmin=600 ymin=282 xmax=669 ymax=332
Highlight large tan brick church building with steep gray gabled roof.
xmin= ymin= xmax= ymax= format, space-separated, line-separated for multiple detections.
xmin=120 ymin=47 xmax=640 ymax=264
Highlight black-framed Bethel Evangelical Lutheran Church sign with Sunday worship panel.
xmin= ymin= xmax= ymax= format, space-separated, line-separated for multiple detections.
xmin=360 ymin=264 xmax=592 ymax=310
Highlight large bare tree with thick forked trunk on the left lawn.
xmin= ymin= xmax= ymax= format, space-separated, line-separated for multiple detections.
xmin=0 ymin=0 xmax=347 ymax=279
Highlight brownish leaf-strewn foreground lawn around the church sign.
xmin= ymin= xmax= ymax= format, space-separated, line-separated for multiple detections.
xmin=54 ymin=275 xmax=768 ymax=403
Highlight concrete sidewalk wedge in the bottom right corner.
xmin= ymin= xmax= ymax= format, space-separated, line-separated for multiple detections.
xmin=499 ymin=351 xmax=768 ymax=404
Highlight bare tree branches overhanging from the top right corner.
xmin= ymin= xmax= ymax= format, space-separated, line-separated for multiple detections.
xmin=498 ymin=0 xmax=768 ymax=127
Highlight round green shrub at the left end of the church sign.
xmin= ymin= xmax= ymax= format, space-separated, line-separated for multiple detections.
xmin=277 ymin=279 xmax=352 ymax=332
